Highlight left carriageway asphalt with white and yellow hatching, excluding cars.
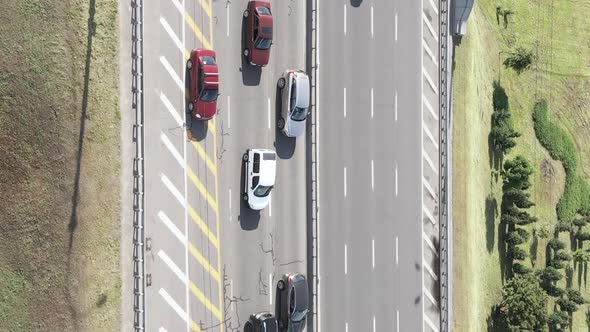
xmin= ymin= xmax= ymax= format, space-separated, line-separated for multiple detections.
xmin=144 ymin=0 xmax=307 ymax=331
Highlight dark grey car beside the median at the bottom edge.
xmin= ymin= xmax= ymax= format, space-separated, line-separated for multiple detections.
xmin=276 ymin=273 xmax=309 ymax=332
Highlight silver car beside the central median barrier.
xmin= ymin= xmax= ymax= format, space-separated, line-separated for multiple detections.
xmin=277 ymin=70 xmax=311 ymax=137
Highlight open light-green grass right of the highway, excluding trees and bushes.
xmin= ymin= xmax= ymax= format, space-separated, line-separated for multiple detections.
xmin=453 ymin=0 xmax=590 ymax=331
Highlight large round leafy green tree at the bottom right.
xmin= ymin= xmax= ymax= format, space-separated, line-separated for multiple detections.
xmin=500 ymin=273 xmax=547 ymax=331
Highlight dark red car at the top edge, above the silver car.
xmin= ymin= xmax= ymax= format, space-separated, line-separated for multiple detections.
xmin=244 ymin=0 xmax=272 ymax=66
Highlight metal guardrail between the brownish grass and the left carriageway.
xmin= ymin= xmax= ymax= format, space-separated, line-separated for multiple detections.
xmin=131 ymin=0 xmax=145 ymax=331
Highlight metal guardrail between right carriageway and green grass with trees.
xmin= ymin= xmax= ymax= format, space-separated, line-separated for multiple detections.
xmin=438 ymin=0 xmax=452 ymax=332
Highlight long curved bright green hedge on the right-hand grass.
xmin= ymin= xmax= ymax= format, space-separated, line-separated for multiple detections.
xmin=533 ymin=100 xmax=590 ymax=221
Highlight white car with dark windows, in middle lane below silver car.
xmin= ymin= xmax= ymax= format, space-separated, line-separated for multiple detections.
xmin=242 ymin=149 xmax=277 ymax=210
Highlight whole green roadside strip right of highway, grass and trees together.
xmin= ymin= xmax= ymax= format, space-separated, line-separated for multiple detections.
xmin=453 ymin=0 xmax=590 ymax=331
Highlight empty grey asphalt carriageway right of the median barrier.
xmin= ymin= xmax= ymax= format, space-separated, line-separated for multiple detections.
xmin=316 ymin=0 xmax=438 ymax=331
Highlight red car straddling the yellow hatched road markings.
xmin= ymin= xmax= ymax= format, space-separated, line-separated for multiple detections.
xmin=186 ymin=48 xmax=219 ymax=120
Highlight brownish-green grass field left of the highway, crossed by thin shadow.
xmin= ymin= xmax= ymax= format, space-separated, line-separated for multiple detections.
xmin=0 ymin=0 xmax=121 ymax=331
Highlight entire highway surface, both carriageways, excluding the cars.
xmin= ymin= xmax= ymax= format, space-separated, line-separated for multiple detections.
xmin=144 ymin=0 xmax=438 ymax=331
